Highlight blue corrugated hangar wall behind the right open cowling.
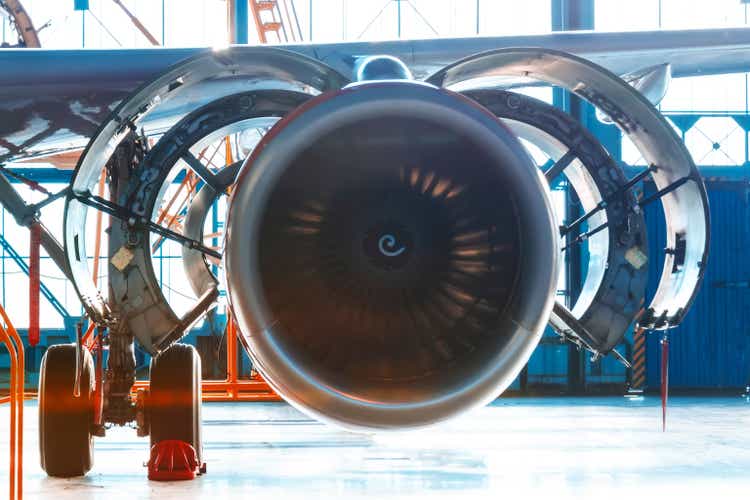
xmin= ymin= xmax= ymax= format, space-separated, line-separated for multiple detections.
xmin=646 ymin=182 xmax=750 ymax=389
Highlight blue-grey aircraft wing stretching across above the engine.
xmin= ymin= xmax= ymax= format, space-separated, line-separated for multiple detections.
xmin=0 ymin=28 xmax=750 ymax=162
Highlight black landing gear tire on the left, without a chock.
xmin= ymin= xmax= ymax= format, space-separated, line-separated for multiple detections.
xmin=39 ymin=344 xmax=95 ymax=477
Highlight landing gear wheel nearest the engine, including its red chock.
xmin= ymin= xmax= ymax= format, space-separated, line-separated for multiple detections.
xmin=147 ymin=344 xmax=205 ymax=480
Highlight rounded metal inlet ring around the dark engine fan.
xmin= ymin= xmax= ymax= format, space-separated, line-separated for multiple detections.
xmin=225 ymin=82 xmax=557 ymax=429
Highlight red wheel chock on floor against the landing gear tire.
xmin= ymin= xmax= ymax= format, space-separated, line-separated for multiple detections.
xmin=148 ymin=440 xmax=206 ymax=481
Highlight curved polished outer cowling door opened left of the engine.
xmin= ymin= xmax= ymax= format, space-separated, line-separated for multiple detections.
xmin=64 ymin=47 xmax=347 ymax=332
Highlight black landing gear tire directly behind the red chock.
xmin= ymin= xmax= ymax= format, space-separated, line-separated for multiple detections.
xmin=148 ymin=344 xmax=203 ymax=464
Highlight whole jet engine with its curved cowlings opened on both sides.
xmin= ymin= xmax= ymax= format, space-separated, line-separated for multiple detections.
xmin=64 ymin=47 xmax=709 ymax=439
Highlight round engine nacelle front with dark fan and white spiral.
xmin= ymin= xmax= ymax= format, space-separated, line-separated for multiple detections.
xmin=225 ymin=82 xmax=558 ymax=428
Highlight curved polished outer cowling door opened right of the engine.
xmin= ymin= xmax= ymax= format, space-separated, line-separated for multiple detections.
xmin=428 ymin=48 xmax=709 ymax=332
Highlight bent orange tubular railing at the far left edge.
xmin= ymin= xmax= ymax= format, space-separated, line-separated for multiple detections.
xmin=0 ymin=306 xmax=25 ymax=500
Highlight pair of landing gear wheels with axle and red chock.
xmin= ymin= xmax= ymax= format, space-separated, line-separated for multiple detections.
xmin=39 ymin=343 xmax=206 ymax=481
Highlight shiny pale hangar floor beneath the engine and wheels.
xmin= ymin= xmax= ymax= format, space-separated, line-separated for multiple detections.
xmin=0 ymin=397 xmax=750 ymax=500
